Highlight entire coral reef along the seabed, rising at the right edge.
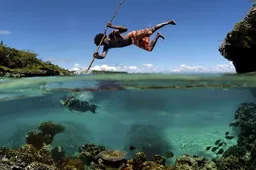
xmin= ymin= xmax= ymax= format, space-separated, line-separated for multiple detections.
xmin=0 ymin=103 xmax=256 ymax=170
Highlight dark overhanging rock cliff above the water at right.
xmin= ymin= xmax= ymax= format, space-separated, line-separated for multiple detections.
xmin=219 ymin=4 xmax=256 ymax=73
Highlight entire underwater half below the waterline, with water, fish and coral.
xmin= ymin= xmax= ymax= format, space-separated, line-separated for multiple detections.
xmin=0 ymin=74 xmax=256 ymax=170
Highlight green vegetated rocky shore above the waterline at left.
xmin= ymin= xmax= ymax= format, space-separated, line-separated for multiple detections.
xmin=0 ymin=41 xmax=71 ymax=77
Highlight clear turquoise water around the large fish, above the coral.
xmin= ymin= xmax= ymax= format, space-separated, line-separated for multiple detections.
xmin=0 ymin=74 xmax=256 ymax=164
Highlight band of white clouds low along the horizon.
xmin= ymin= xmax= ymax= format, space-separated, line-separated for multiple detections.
xmin=71 ymin=63 xmax=235 ymax=73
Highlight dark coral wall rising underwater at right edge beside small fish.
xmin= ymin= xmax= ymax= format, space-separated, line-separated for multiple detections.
xmin=216 ymin=103 xmax=256 ymax=170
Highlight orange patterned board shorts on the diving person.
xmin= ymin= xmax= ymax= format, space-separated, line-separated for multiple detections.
xmin=128 ymin=28 xmax=153 ymax=51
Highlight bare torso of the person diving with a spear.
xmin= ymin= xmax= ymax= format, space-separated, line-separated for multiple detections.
xmin=104 ymin=33 xmax=132 ymax=49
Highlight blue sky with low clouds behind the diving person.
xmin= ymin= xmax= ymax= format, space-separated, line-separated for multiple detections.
xmin=0 ymin=0 xmax=252 ymax=72
